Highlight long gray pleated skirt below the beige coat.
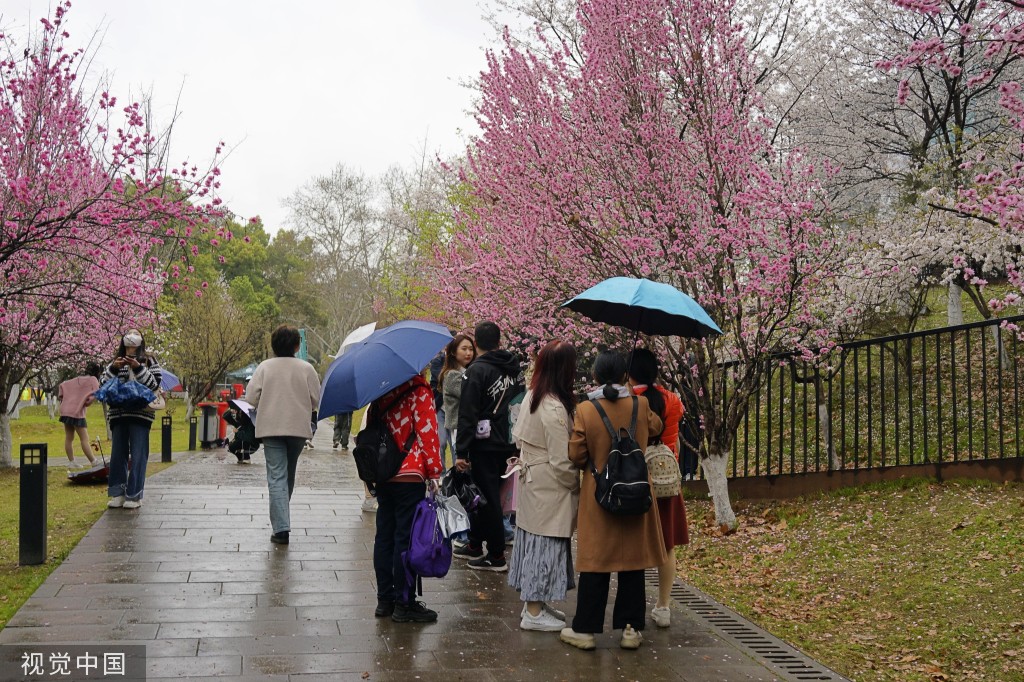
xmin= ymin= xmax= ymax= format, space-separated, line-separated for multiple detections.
xmin=509 ymin=527 xmax=575 ymax=601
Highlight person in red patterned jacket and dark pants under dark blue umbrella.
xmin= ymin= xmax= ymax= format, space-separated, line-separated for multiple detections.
xmin=369 ymin=375 xmax=441 ymax=623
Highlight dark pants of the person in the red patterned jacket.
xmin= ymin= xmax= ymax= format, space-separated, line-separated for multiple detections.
xmin=374 ymin=482 xmax=426 ymax=603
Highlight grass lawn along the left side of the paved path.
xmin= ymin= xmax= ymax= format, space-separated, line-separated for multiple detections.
xmin=0 ymin=400 xmax=182 ymax=629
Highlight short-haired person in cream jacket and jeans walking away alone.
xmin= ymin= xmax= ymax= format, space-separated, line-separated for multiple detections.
xmin=245 ymin=325 xmax=319 ymax=545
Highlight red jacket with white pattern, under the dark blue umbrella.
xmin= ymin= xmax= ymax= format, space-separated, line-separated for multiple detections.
xmin=374 ymin=375 xmax=441 ymax=480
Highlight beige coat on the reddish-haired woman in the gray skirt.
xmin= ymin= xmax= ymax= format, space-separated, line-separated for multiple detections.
xmin=512 ymin=391 xmax=580 ymax=538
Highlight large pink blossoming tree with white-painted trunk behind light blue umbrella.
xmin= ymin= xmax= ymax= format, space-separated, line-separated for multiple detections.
xmin=433 ymin=0 xmax=841 ymax=527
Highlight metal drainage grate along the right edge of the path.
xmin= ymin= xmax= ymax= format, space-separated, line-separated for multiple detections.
xmin=646 ymin=568 xmax=849 ymax=682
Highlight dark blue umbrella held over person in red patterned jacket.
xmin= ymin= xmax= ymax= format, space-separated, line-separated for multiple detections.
xmin=317 ymin=319 xmax=452 ymax=419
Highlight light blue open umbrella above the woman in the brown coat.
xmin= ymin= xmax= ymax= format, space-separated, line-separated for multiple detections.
xmin=562 ymin=278 xmax=722 ymax=339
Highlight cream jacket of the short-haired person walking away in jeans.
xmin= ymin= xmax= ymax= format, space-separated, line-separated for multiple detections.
xmin=246 ymin=357 xmax=319 ymax=438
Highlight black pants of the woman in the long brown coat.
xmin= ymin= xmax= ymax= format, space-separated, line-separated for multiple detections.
xmin=572 ymin=570 xmax=647 ymax=635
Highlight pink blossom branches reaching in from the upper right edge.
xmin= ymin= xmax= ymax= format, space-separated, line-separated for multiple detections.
xmin=879 ymin=0 xmax=1024 ymax=317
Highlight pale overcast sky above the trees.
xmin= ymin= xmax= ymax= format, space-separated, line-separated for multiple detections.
xmin=9 ymin=0 xmax=495 ymax=232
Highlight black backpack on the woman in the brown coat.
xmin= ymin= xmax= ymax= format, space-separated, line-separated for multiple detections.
xmin=590 ymin=395 xmax=653 ymax=516
